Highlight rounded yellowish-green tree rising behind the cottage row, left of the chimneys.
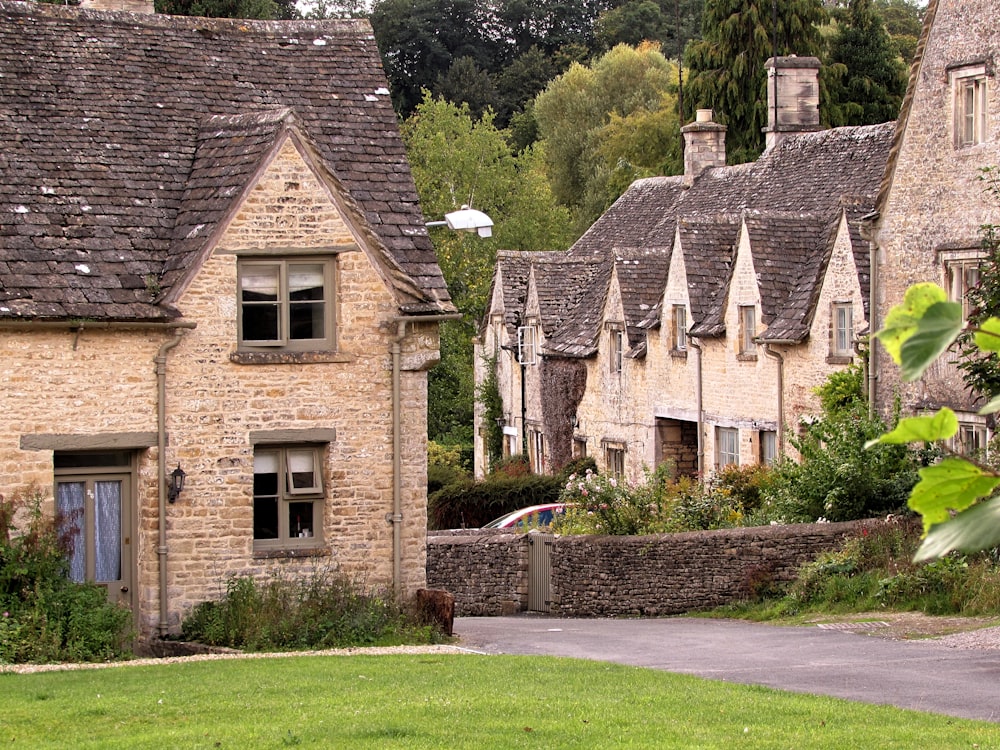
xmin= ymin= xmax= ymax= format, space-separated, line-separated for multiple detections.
xmin=535 ymin=44 xmax=680 ymax=231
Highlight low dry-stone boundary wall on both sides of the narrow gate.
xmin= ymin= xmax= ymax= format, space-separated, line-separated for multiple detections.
xmin=427 ymin=522 xmax=859 ymax=617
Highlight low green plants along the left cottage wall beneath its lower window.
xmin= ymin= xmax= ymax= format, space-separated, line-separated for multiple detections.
xmin=181 ymin=569 xmax=434 ymax=651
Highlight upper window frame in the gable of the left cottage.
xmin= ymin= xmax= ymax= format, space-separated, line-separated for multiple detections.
xmin=237 ymin=256 xmax=337 ymax=352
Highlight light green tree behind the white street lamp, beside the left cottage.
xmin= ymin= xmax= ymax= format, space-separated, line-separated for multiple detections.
xmin=402 ymin=91 xmax=574 ymax=451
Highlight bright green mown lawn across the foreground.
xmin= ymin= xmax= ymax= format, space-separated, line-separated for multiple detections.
xmin=0 ymin=654 xmax=1000 ymax=750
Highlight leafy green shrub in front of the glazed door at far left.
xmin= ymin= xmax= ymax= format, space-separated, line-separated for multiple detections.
xmin=0 ymin=490 xmax=132 ymax=663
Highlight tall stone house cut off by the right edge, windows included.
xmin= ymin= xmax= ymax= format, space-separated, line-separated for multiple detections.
xmin=869 ymin=0 xmax=1000 ymax=450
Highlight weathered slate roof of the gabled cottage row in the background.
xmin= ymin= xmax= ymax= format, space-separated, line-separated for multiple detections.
xmin=496 ymin=123 xmax=894 ymax=357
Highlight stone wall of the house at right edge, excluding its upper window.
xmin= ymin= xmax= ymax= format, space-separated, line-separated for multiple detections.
xmin=873 ymin=0 xmax=1000 ymax=412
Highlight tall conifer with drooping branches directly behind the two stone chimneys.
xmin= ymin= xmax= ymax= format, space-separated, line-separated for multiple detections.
xmin=684 ymin=0 xmax=828 ymax=164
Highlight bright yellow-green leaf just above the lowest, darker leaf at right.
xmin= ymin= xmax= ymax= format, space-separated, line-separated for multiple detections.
xmin=908 ymin=458 xmax=1000 ymax=533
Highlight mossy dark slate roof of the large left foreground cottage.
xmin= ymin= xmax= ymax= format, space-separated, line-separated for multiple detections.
xmin=0 ymin=0 xmax=454 ymax=321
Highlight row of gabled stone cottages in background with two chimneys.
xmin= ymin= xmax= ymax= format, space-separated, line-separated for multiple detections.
xmin=476 ymin=56 xmax=894 ymax=480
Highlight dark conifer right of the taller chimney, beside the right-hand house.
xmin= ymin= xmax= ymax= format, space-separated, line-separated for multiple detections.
xmin=829 ymin=0 xmax=907 ymax=126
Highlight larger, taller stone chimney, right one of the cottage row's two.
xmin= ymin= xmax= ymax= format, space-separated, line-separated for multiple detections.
xmin=764 ymin=55 xmax=823 ymax=151
